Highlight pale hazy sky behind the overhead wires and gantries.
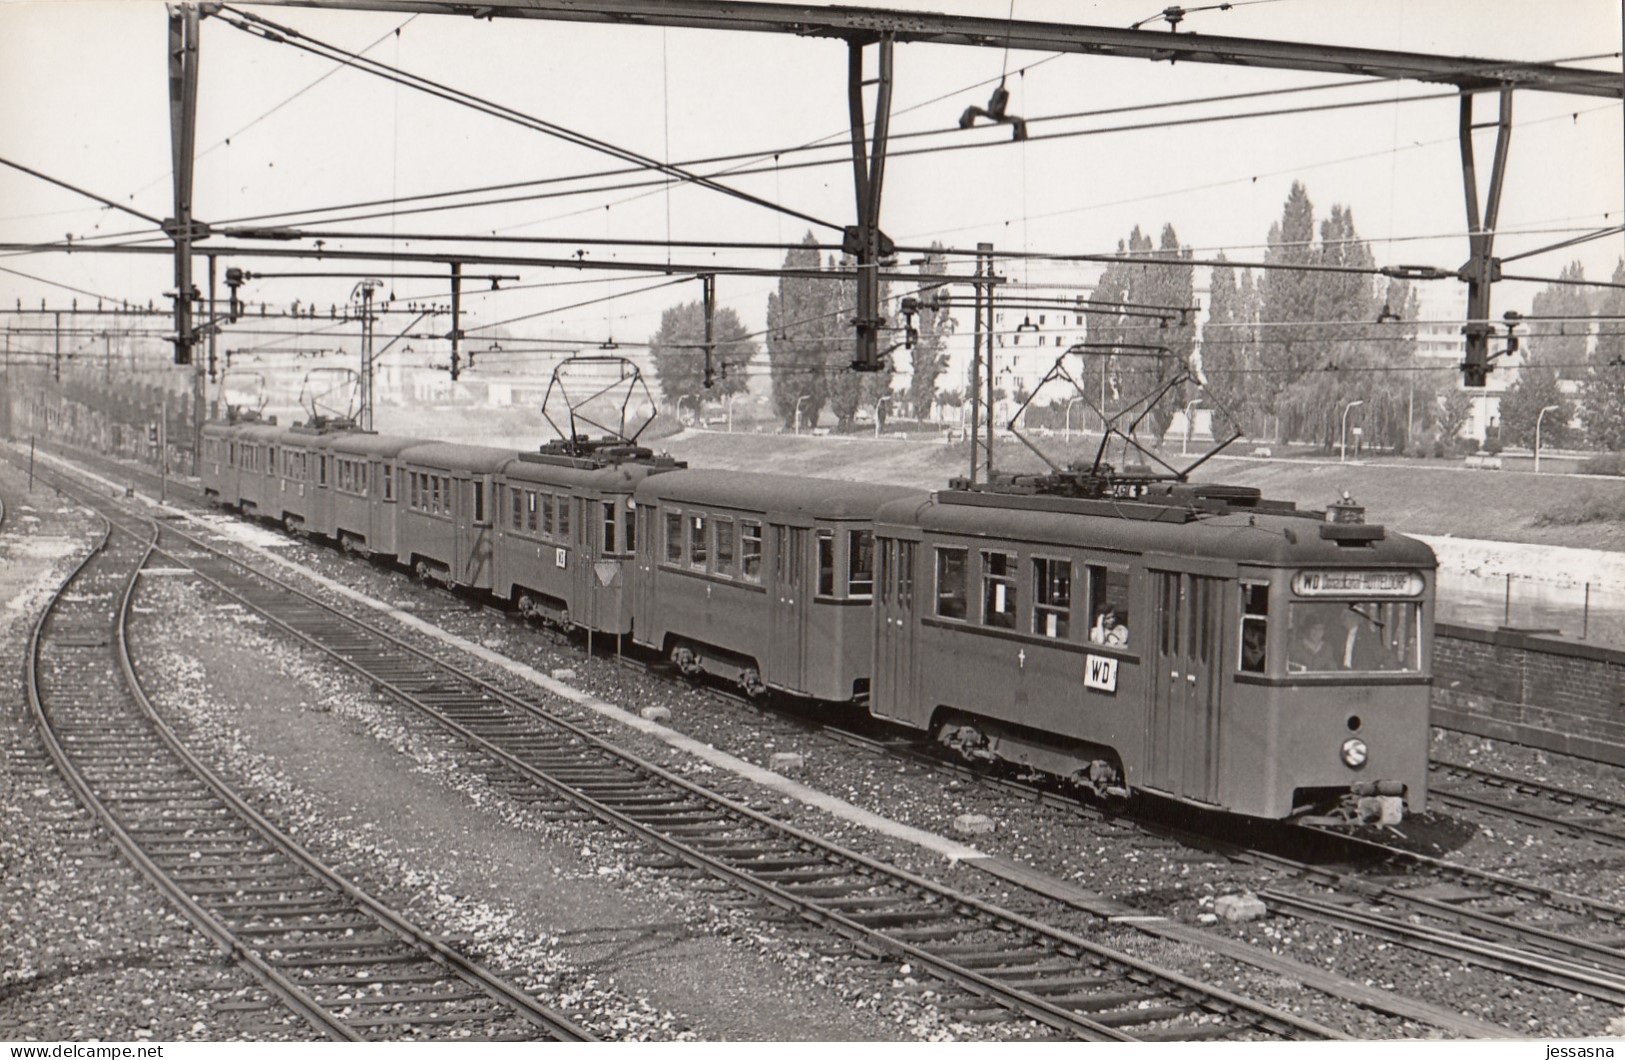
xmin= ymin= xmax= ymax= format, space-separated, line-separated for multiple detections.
xmin=0 ymin=0 xmax=1625 ymax=378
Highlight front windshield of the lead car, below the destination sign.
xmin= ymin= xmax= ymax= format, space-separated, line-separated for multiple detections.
xmin=1287 ymin=600 xmax=1422 ymax=673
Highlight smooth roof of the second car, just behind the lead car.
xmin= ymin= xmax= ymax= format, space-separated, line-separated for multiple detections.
xmin=637 ymin=470 xmax=926 ymax=519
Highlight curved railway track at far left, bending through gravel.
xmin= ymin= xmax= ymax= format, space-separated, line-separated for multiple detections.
xmin=26 ymin=507 xmax=590 ymax=1040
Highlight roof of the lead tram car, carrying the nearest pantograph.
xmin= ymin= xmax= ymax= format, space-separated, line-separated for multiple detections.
xmin=876 ymin=491 xmax=1437 ymax=569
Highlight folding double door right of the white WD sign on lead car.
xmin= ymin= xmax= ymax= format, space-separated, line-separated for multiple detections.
xmin=1144 ymin=569 xmax=1225 ymax=802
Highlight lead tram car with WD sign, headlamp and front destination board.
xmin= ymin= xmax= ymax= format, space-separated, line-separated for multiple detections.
xmin=873 ymin=483 xmax=1435 ymax=823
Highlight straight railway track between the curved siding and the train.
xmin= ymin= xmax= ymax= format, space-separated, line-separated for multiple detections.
xmin=31 ymin=451 xmax=1341 ymax=1040
